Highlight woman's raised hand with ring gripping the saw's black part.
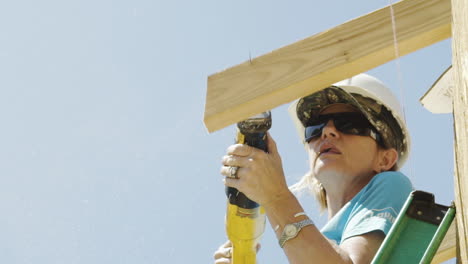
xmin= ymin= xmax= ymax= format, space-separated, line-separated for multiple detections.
xmin=221 ymin=133 xmax=290 ymax=205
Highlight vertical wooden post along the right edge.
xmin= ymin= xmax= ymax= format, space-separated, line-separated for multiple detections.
xmin=452 ymin=0 xmax=468 ymax=264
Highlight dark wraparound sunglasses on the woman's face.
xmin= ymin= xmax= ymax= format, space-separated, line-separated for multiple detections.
xmin=305 ymin=112 xmax=383 ymax=146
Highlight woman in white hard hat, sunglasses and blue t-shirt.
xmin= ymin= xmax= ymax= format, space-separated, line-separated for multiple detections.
xmin=215 ymin=74 xmax=412 ymax=264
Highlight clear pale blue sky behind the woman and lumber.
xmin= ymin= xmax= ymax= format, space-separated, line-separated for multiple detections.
xmin=0 ymin=0 xmax=453 ymax=264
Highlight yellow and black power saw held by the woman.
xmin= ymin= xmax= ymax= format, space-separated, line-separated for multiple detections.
xmin=226 ymin=111 xmax=271 ymax=264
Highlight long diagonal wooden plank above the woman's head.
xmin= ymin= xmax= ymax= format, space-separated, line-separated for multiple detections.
xmin=204 ymin=0 xmax=451 ymax=132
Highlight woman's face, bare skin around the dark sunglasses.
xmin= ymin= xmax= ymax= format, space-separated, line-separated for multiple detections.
xmin=309 ymin=104 xmax=379 ymax=184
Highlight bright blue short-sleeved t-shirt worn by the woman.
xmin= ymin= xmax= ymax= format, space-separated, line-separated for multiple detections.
xmin=321 ymin=171 xmax=412 ymax=245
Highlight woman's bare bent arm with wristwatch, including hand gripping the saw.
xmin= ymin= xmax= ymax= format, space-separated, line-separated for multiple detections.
xmin=221 ymin=135 xmax=384 ymax=264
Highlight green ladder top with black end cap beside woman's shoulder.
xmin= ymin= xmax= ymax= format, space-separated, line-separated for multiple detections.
xmin=372 ymin=191 xmax=455 ymax=264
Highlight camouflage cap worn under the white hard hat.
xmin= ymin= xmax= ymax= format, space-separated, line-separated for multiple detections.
xmin=296 ymin=86 xmax=406 ymax=153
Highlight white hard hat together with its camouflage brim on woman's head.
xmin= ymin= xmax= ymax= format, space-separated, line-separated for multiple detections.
xmin=289 ymin=74 xmax=410 ymax=168
